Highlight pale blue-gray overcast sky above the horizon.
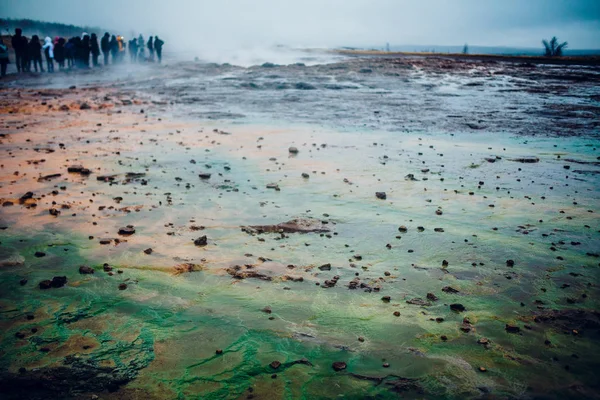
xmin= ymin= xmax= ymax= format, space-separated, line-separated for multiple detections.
xmin=0 ymin=0 xmax=600 ymax=49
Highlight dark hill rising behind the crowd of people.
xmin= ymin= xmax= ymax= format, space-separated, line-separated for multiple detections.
xmin=0 ymin=18 xmax=105 ymax=38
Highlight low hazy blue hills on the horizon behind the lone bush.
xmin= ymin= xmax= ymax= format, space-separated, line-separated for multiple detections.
xmin=356 ymin=44 xmax=600 ymax=56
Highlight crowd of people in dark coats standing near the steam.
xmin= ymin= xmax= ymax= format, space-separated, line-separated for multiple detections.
xmin=0 ymin=28 xmax=165 ymax=76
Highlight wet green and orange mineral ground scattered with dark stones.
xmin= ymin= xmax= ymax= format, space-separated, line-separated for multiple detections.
xmin=0 ymin=54 xmax=600 ymax=399
